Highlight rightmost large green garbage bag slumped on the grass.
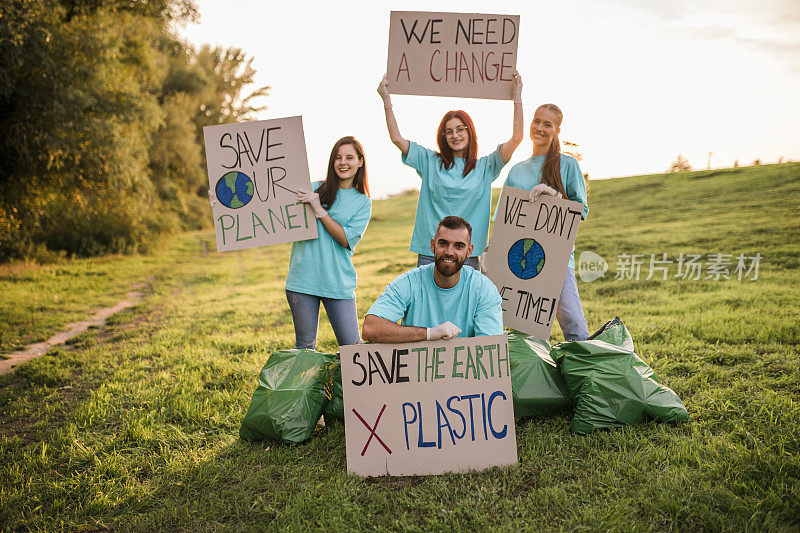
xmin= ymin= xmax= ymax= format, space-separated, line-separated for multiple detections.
xmin=550 ymin=318 xmax=690 ymax=434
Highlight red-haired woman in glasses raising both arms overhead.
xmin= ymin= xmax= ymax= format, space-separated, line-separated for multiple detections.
xmin=378 ymin=71 xmax=524 ymax=269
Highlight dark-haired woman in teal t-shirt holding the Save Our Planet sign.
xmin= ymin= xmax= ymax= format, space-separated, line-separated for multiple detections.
xmin=286 ymin=137 xmax=372 ymax=349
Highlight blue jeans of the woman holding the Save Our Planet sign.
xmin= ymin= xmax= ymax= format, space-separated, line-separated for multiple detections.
xmin=286 ymin=290 xmax=361 ymax=350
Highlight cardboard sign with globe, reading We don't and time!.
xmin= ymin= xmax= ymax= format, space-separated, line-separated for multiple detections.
xmin=486 ymin=186 xmax=583 ymax=339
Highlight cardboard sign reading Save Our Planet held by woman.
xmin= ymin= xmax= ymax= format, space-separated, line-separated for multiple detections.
xmin=203 ymin=117 xmax=317 ymax=252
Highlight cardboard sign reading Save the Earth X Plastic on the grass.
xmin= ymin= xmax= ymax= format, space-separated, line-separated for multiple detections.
xmin=340 ymin=335 xmax=517 ymax=476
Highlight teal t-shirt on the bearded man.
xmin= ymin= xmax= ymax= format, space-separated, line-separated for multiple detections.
xmin=367 ymin=263 xmax=503 ymax=337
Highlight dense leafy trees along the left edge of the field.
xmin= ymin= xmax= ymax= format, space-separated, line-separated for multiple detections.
xmin=0 ymin=0 xmax=269 ymax=261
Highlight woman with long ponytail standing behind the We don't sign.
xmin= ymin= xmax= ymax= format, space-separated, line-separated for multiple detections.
xmin=504 ymin=104 xmax=589 ymax=341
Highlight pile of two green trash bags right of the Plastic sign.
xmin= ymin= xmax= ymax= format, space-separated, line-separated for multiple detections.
xmin=508 ymin=318 xmax=690 ymax=435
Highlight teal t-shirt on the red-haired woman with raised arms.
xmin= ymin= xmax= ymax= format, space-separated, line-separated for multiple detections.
xmin=402 ymin=142 xmax=505 ymax=257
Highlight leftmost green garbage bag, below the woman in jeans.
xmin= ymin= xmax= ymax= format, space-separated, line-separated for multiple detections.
xmin=239 ymin=350 xmax=339 ymax=443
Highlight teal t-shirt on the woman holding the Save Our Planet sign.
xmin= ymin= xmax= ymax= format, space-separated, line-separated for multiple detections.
xmin=286 ymin=181 xmax=372 ymax=300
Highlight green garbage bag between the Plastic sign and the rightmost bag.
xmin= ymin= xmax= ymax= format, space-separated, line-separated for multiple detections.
xmin=508 ymin=330 xmax=572 ymax=418
